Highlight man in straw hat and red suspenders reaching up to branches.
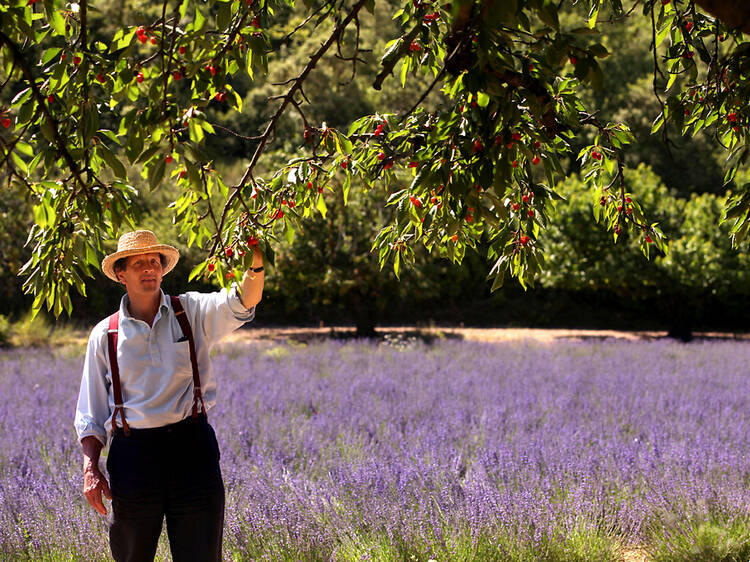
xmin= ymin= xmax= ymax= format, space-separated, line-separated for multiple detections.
xmin=75 ymin=230 xmax=264 ymax=562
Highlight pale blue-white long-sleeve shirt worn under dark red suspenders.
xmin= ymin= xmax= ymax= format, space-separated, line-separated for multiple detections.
xmin=74 ymin=286 xmax=255 ymax=444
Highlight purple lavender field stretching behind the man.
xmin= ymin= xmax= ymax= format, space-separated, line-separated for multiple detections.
xmin=0 ymin=334 xmax=750 ymax=562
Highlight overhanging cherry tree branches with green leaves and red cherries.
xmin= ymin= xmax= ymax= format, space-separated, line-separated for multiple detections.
xmin=0 ymin=0 xmax=750 ymax=314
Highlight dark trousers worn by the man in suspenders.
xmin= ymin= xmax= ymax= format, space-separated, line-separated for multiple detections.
xmin=107 ymin=415 xmax=224 ymax=562
